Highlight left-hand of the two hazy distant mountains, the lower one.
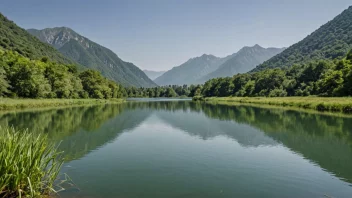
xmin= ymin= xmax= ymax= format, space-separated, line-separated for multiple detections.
xmin=154 ymin=54 xmax=235 ymax=85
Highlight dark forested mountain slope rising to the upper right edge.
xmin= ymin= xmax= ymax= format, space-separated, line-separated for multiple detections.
xmin=253 ymin=6 xmax=352 ymax=71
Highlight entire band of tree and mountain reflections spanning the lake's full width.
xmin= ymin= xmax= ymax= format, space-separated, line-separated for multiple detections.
xmin=0 ymin=101 xmax=352 ymax=182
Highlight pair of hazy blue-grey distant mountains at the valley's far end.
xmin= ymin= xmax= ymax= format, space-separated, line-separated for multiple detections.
xmin=154 ymin=45 xmax=284 ymax=85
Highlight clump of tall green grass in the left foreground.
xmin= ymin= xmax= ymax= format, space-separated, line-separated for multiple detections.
xmin=0 ymin=127 xmax=63 ymax=198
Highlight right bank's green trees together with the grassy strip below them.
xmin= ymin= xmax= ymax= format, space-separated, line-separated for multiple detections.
xmin=193 ymin=50 xmax=352 ymax=113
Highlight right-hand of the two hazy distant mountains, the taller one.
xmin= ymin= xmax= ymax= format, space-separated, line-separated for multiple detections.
xmin=200 ymin=45 xmax=284 ymax=83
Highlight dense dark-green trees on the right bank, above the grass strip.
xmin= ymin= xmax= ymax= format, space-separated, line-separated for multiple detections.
xmin=201 ymin=50 xmax=352 ymax=97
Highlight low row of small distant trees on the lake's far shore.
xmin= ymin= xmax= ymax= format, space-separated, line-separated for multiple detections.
xmin=126 ymin=85 xmax=201 ymax=98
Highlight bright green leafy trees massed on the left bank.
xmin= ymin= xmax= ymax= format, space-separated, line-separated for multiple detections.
xmin=0 ymin=50 xmax=124 ymax=99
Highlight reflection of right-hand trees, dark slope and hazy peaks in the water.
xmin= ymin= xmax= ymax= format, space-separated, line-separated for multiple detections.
xmin=126 ymin=102 xmax=352 ymax=182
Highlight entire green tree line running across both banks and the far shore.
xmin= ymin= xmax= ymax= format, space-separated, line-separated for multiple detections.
xmin=0 ymin=47 xmax=352 ymax=99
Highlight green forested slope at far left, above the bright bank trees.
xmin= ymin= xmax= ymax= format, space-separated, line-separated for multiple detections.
xmin=0 ymin=13 xmax=74 ymax=64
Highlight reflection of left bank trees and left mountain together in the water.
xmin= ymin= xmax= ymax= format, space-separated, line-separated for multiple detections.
xmin=0 ymin=105 xmax=149 ymax=161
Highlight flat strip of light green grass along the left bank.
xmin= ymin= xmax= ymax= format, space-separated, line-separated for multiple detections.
xmin=0 ymin=98 xmax=125 ymax=110
